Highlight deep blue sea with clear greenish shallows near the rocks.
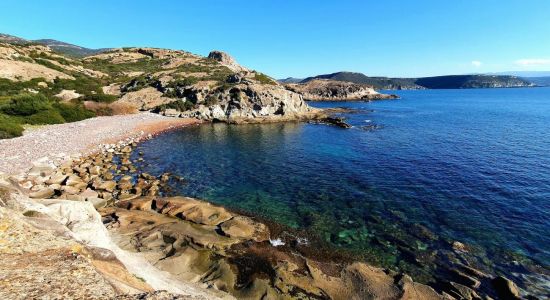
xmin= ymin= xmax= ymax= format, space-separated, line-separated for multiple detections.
xmin=138 ymin=88 xmax=550 ymax=290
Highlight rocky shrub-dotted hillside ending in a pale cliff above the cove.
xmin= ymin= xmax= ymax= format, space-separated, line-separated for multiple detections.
xmin=0 ymin=35 xmax=315 ymax=138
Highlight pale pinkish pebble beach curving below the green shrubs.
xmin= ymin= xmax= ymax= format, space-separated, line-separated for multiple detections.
xmin=0 ymin=113 xmax=198 ymax=174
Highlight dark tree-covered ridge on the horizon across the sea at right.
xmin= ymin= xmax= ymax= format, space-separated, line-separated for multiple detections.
xmin=294 ymin=72 xmax=537 ymax=90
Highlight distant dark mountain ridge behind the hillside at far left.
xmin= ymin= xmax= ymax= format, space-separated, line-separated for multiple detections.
xmin=0 ymin=33 xmax=110 ymax=58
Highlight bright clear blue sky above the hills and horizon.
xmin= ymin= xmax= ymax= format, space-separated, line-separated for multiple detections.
xmin=0 ymin=0 xmax=550 ymax=78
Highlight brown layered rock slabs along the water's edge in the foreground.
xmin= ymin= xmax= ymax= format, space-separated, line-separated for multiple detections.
xmin=100 ymin=197 xmax=446 ymax=299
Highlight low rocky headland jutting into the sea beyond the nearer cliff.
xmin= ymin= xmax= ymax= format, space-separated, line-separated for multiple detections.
xmin=285 ymin=79 xmax=397 ymax=101
